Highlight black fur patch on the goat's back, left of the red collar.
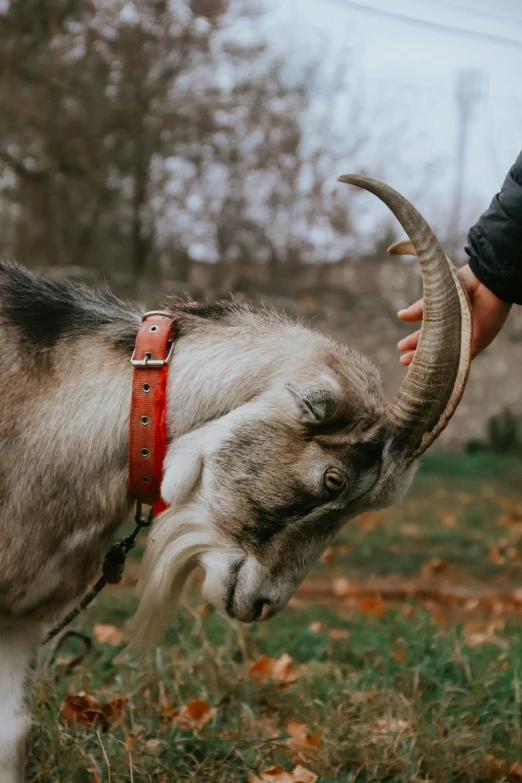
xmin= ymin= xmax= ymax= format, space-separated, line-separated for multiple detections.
xmin=0 ymin=263 xmax=139 ymax=352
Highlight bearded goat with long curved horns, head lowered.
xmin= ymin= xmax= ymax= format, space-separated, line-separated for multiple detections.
xmin=0 ymin=177 xmax=470 ymax=783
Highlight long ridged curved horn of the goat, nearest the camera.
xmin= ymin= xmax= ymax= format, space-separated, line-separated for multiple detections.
xmin=339 ymin=175 xmax=471 ymax=458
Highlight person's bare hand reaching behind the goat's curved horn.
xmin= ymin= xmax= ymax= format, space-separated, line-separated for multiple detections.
xmin=397 ymin=264 xmax=512 ymax=367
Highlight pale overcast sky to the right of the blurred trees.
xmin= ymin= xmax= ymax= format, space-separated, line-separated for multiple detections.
xmin=271 ymin=0 xmax=522 ymax=230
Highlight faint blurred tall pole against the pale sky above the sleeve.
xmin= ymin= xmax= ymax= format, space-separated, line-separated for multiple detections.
xmin=451 ymin=68 xmax=486 ymax=254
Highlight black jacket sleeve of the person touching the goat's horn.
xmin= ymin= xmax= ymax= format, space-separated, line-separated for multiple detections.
xmin=466 ymin=152 xmax=522 ymax=304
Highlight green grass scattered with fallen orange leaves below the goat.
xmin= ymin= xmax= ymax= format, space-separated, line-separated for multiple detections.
xmin=27 ymin=454 xmax=522 ymax=783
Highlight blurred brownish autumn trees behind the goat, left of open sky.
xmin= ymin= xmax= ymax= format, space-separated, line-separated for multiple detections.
xmin=0 ymin=0 xmax=394 ymax=286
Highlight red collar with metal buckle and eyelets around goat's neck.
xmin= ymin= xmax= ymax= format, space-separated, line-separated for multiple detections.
xmin=129 ymin=310 xmax=175 ymax=514
